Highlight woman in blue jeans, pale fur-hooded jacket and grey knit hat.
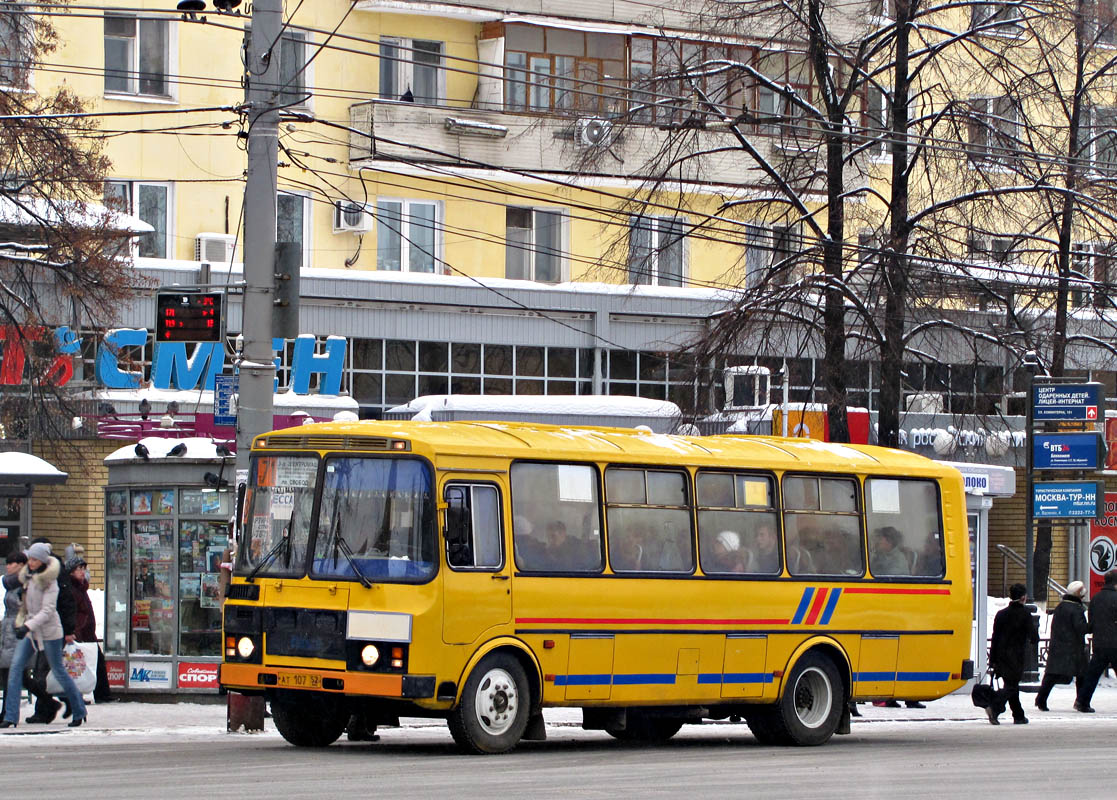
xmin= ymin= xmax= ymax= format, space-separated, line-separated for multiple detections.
xmin=0 ymin=542 xmax=86 ymax=727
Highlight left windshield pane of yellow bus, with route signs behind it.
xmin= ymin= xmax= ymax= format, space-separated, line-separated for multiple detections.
xmin=237 ymin=456 xmax=318 ymax=578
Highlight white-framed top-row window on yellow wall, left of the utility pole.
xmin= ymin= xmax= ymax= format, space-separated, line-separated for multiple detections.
xmin=105 ymin=13 xmax=170 ymax=97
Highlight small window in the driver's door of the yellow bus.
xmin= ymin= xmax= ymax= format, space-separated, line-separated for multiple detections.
xmin=446 ymin=484 xmax=503 ymax=569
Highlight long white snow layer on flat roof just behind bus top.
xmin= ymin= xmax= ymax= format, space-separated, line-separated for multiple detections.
xmin=389 ymin=394 xmax=682 ymax=420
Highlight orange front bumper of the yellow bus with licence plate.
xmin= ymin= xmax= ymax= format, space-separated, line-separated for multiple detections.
xmin=220 ymin=663 xmax=435 ymax=699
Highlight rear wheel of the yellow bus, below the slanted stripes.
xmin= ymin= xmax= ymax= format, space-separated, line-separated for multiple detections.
xmin=771 ymin=651 xmax=846 ymax=746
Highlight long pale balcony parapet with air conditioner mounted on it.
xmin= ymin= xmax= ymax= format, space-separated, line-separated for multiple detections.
xmin=350 ymin=101 xmax=813 ymax=185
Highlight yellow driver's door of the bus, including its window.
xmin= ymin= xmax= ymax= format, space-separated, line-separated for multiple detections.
xmin=442 ymin=480 xmax=512 ymax=645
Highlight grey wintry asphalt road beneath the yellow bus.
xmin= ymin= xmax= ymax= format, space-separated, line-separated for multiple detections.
xmin=0 ymin=715 xmax=1117 ymax=800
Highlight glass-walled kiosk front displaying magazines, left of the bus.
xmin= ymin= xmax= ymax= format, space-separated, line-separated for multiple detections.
xmin=105 ymin=486 xmax=232 ymax=688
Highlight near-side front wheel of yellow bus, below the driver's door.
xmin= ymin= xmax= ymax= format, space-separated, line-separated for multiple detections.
xmin=448 ymin=653 xmax=532 ymax=755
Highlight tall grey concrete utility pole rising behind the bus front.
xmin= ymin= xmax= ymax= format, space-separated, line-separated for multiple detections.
xmin=237 ymin=0 xmax=283 ymax=470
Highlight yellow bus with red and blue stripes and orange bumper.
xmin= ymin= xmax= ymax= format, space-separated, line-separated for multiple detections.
xmin=221 ymin=421 xmax=973 ymax=753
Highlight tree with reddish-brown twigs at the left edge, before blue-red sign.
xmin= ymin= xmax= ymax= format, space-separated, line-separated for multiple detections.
xmin=0 ymin=2 xmax=137 ymax=436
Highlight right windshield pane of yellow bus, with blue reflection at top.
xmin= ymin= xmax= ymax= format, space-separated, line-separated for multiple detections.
xmin=312 ymin=457 xmax=438 ymax=582
